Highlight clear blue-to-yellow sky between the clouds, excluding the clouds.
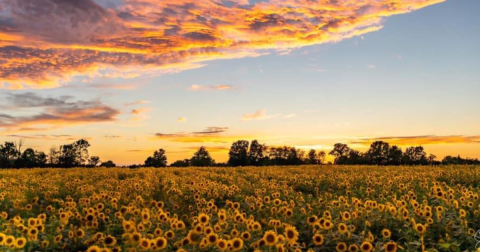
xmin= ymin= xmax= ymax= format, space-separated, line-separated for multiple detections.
xmin=0 ymin=0 xmax=480 ymax=163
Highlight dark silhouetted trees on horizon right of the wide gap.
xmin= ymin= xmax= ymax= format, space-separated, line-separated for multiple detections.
xmin=144 ymin=140 xmax=480 ymax=167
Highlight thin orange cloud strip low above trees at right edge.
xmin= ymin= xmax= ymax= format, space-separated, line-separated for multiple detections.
xmin=350 ymin=135 xmax=480 ymax=146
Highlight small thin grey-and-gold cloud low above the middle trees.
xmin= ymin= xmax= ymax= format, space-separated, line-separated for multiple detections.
xmin=153 ymin=127 xmax=248 ymax=143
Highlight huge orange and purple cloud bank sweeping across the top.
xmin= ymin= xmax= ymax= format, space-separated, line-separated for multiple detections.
xmin=0 ymin=0 xmax=444 ymax=89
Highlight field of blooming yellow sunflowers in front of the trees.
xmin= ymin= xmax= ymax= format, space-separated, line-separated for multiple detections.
xmin=0 ymin=166 xmax=480 ymax=252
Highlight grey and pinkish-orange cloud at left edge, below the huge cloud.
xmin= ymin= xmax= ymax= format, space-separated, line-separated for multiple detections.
xmin=0 ymin=93 xmax=120 ymax=131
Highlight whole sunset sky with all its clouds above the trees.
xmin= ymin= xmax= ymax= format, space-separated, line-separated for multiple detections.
xmin=0 ymin=0 xmax=480 ymax=165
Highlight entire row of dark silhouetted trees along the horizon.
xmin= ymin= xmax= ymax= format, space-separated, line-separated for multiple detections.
xmin=0 ymin=139 xmax=480 ymax=168
